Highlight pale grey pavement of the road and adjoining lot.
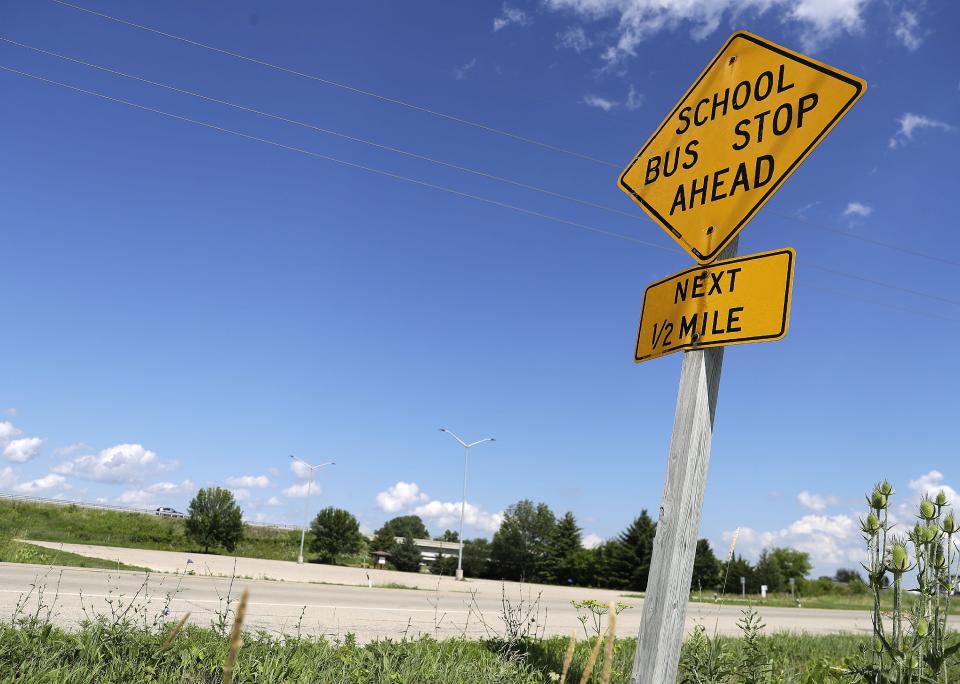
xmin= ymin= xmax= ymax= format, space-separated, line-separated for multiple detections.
xmin=0 ymin=545 xmax=920 ymax=641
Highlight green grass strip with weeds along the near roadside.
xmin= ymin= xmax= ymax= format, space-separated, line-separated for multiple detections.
xmin=0 ymin=621 xmax=960 ymax=684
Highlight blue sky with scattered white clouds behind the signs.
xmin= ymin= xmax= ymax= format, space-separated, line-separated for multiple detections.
xmin=0 ymin=0 xmax=960 ymax=572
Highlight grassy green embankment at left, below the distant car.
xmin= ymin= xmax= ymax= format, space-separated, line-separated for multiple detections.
xmin=0 ymin=501 xmax=326 ymax=561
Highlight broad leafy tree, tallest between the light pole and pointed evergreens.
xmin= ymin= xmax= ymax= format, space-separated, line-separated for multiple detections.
xmin=490 ymin=499 xmax=556 ymax=582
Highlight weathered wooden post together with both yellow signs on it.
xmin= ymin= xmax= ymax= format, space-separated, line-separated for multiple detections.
xmin=618 ymin=31 xmax=866 ymax=684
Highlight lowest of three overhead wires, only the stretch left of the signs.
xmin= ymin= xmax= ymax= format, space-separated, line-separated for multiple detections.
xmin=0 ymin=64 xmax=680 ymax=253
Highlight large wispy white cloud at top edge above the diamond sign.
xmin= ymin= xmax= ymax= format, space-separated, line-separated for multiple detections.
xmin=545 ymin=0 xmax=869 ymax=64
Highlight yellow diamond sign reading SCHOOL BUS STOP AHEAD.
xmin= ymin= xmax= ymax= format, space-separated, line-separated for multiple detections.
xmin=619 ymin=31 xmax=866 ymax=264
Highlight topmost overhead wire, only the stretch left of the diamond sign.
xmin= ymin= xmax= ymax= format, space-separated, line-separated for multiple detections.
xmin=52 ymin=0 xmax=621 ymax=168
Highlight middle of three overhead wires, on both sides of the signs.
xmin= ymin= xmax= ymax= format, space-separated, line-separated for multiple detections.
xmin=0 ymin=35 xmax=960 ymax=306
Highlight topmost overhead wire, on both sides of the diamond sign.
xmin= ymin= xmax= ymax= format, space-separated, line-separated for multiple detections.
xmin=51 ymin=0 xmax=960 ymax=267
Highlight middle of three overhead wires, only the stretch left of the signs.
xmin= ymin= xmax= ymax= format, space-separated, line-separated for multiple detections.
xmin=0 ymin=36 xmax=643 ymax=220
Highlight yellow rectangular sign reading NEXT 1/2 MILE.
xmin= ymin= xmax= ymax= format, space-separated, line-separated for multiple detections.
xmin=634 ymin=248 xmax=796 ymax=363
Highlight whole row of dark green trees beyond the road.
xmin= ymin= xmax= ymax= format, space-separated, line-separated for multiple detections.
xmin=186 ymin=488 xmax=865 ymax=595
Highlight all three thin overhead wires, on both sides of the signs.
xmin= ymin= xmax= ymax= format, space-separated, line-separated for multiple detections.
xmin=0 ymin=0 xmax=960 ymax=322
